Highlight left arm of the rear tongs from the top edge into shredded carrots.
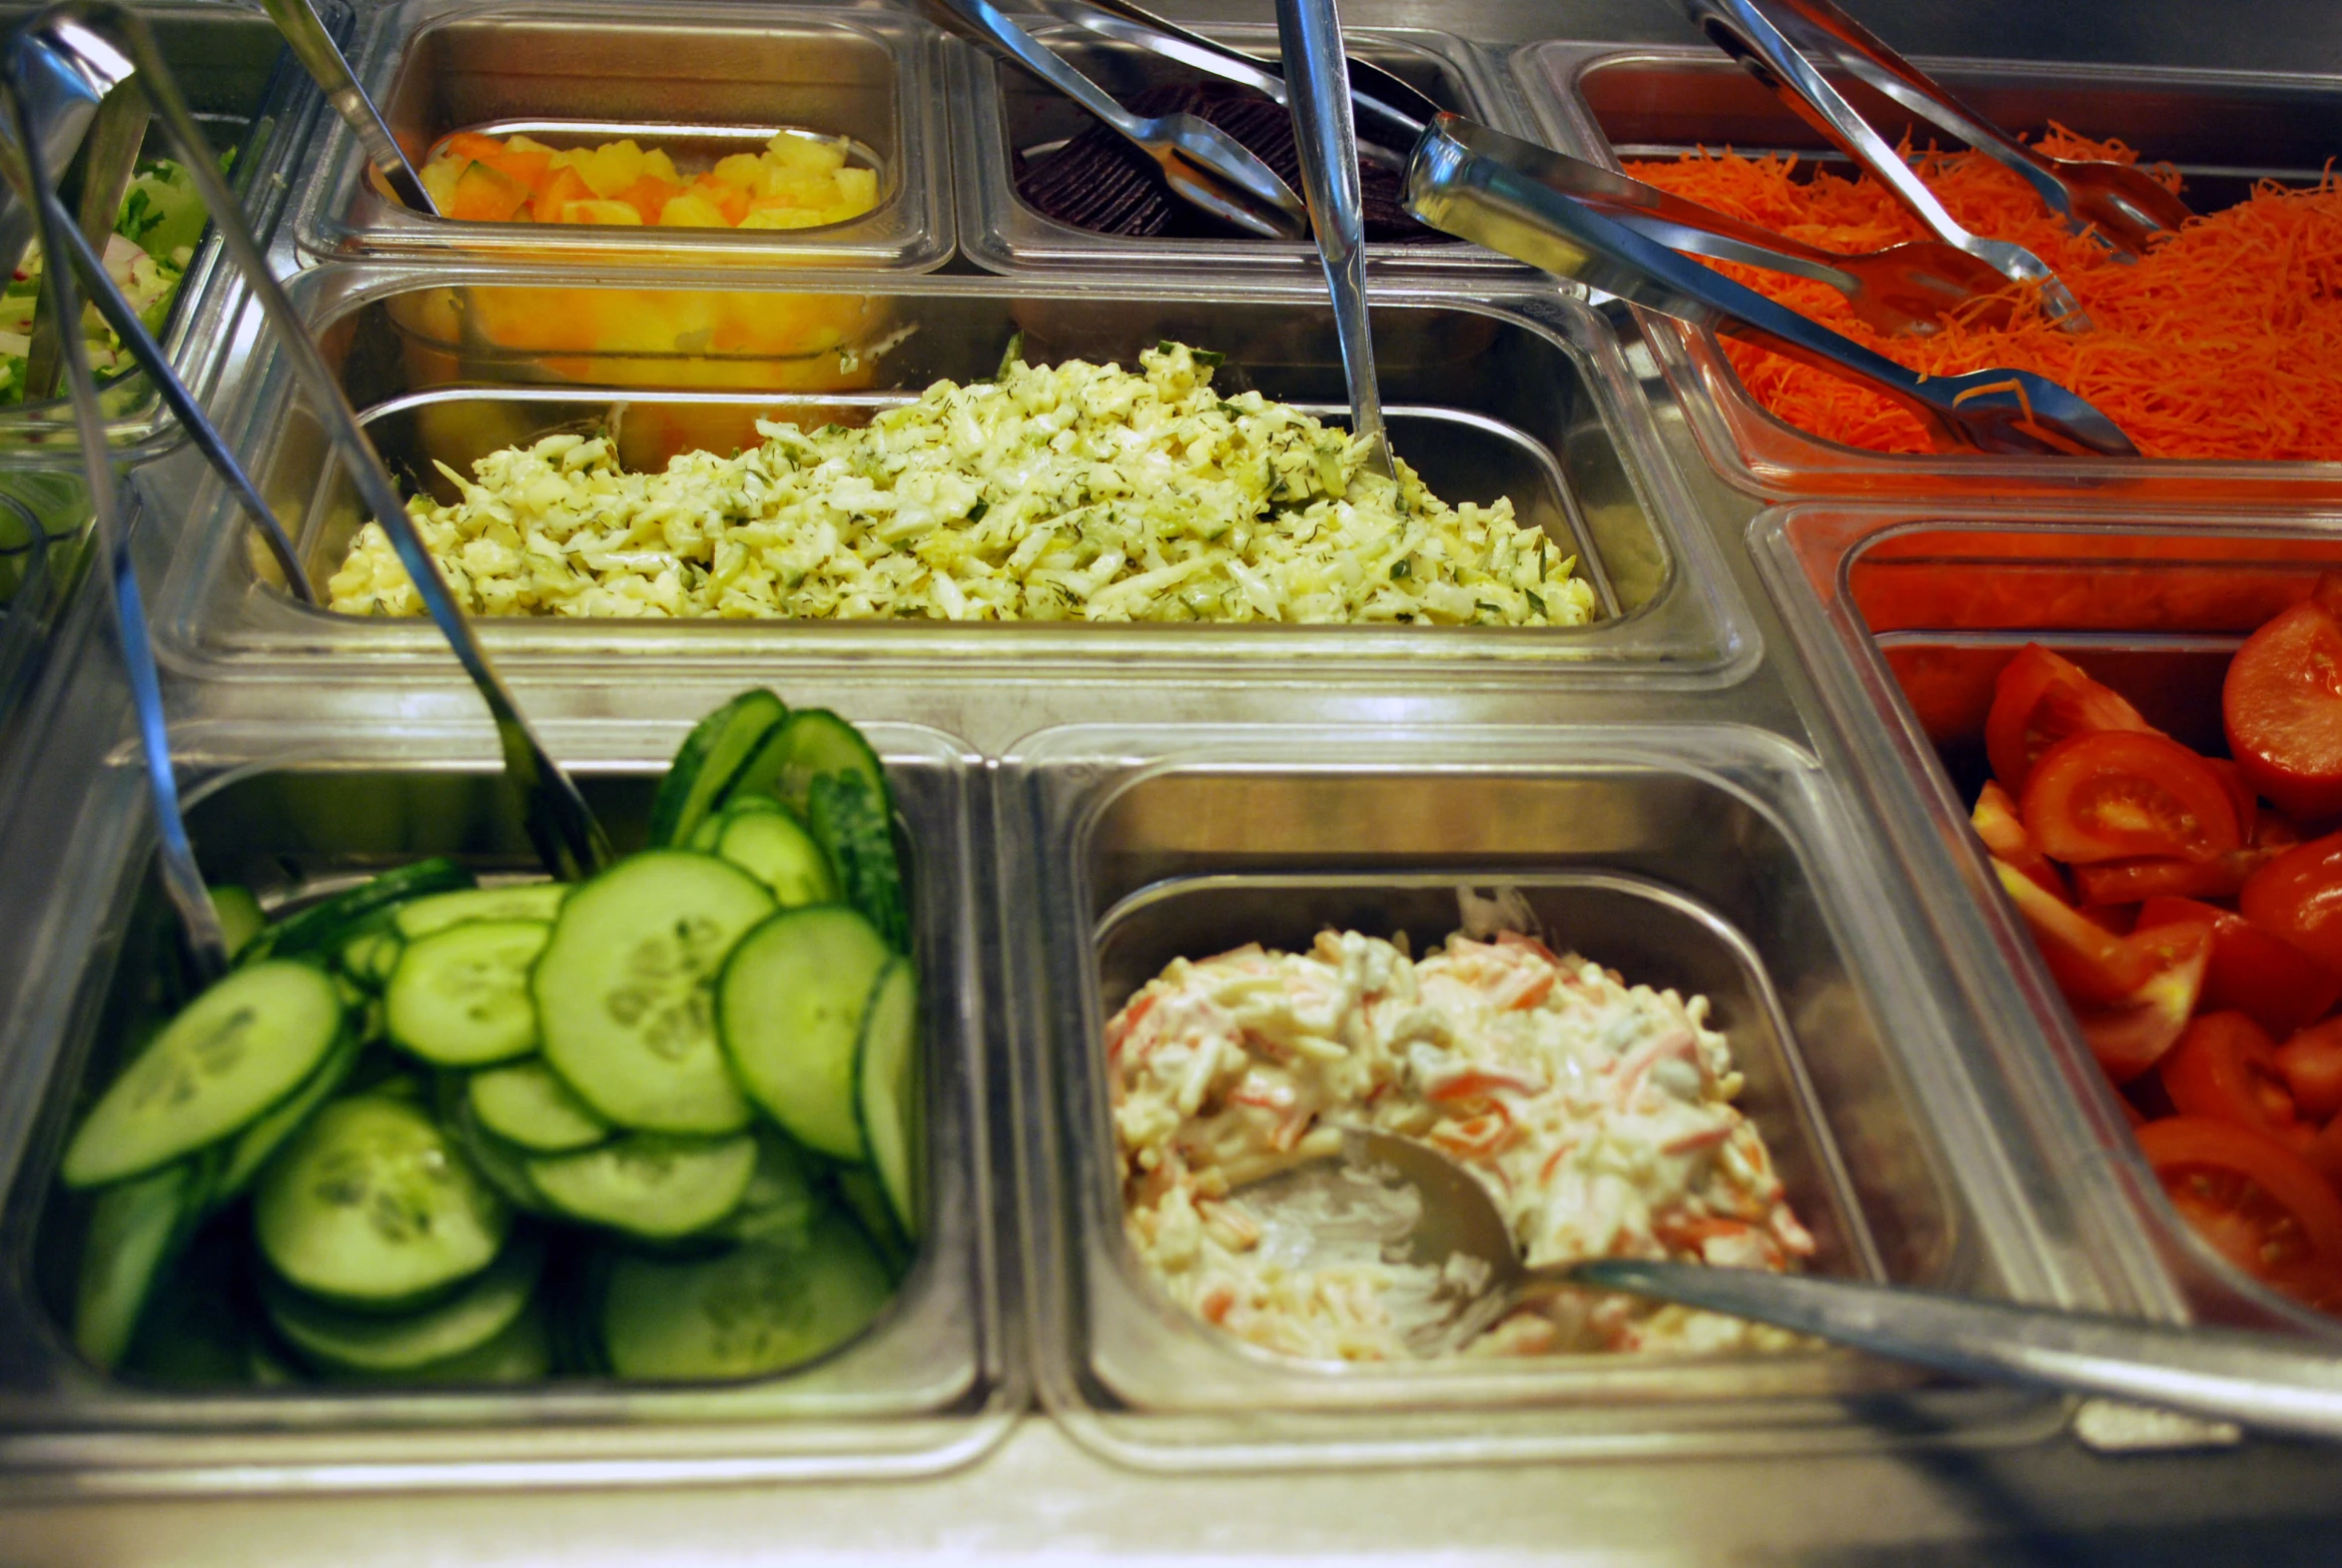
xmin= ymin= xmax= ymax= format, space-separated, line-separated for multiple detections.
xmin=1684 ymin=0 xmax=2089 ymax=333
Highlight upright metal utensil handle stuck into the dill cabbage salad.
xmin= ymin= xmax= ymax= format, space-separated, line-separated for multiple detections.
xmin=1276 ymin=0 xmax=1398 ymax=479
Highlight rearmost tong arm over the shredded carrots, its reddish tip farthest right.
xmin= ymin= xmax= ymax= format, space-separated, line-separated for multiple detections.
xmin=1757 ymin=0 xmax=2194 ymax=258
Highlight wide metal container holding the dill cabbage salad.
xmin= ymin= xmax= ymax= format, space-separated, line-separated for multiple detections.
xmin=157 ymin=267 xmax=1757 ymax=681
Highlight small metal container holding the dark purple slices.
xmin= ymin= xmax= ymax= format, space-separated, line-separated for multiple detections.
xmin=951 ymin=19 xmax=1550 ymax=291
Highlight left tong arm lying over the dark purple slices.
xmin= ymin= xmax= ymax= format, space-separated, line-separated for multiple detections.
xmin=935 ymin=0 xmax=1309 ymax=239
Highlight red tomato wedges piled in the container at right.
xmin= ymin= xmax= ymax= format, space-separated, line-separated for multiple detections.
xmin=1974 ymin=575 xmax=2342 ymax=1313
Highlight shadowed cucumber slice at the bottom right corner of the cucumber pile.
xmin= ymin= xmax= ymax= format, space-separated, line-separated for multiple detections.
xmin=602 ymin=1214 xmax=892 ymax=1381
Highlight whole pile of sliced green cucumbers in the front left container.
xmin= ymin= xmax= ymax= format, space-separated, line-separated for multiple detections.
xmin=59 ymin=690 xmax=921 ymax=1385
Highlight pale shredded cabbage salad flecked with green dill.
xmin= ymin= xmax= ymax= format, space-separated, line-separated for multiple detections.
xmin=331 ymin=344 xmax=1595 ymax=627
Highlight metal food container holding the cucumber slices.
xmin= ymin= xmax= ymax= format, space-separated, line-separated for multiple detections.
xmin=0 ymin=645 xmax=1026 ymax=1495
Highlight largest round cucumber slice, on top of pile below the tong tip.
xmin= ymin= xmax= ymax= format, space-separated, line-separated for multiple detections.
xmin=529 ymin=850 xmax=773 ymax=1133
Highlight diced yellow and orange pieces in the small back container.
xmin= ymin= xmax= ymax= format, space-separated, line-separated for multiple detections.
xmin=421 ymin=131 xmax=878 ymax=230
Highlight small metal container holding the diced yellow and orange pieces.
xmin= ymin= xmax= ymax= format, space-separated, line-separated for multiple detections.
xmin=295 ymin=0 xmax=953 ymax=275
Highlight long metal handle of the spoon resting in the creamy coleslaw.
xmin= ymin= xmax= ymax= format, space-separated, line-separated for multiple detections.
xmin=1571 ymin=1259 xmax=2342 ymax=1437
